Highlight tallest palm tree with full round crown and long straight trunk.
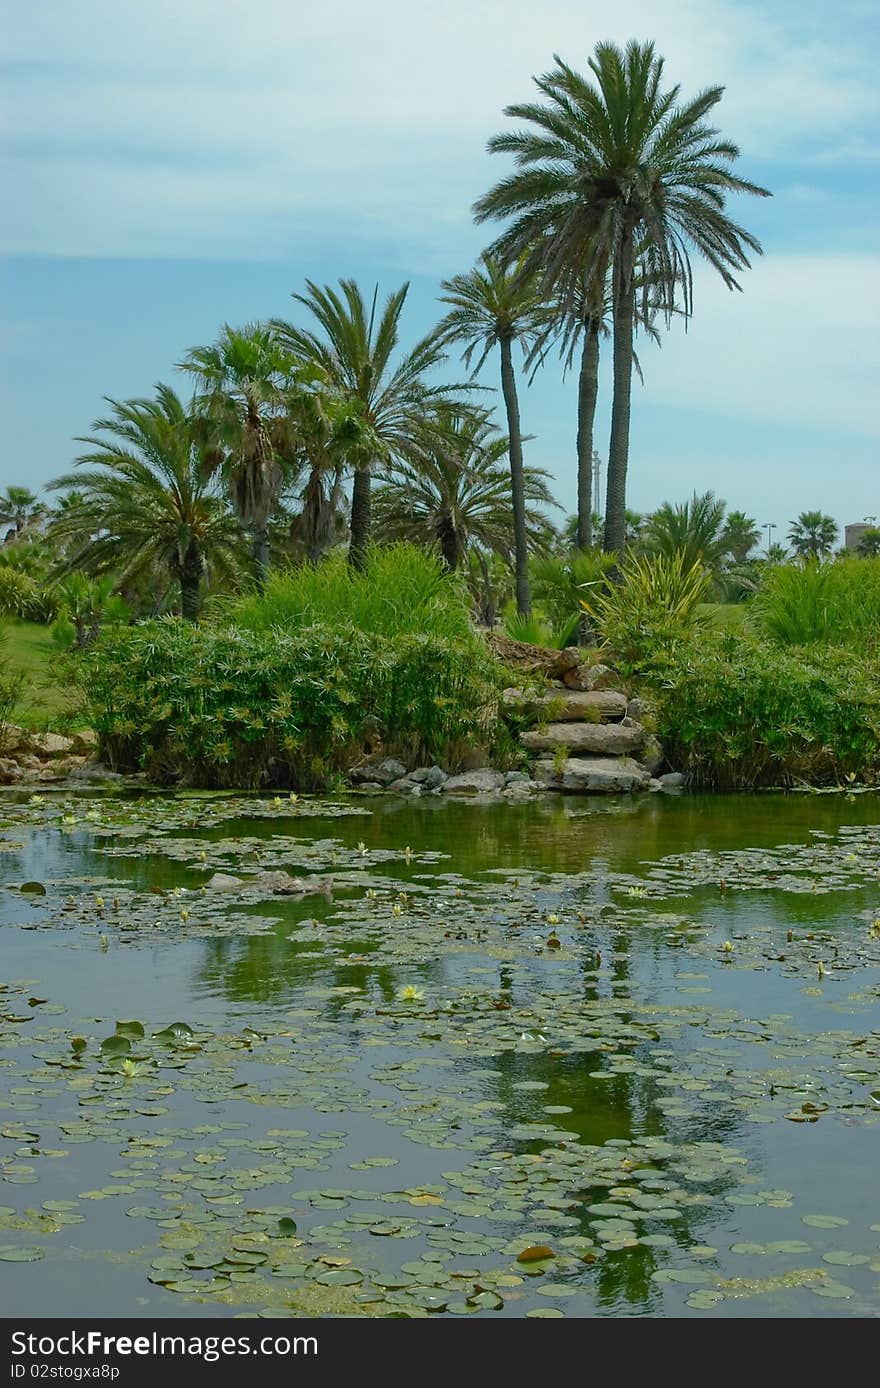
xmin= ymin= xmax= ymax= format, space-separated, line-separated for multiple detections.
xmin=475 ymin=42 xmax=766 ymax=551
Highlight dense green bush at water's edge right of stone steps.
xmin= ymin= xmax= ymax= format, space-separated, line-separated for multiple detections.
xmin=646 ymin=634 xmax=880 ymax=790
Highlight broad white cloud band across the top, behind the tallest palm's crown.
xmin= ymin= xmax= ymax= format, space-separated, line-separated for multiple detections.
xmin=0 ymin=0 xmax=876 ymax=266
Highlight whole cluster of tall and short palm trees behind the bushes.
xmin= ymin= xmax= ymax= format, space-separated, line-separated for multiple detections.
xmin=13 ymin=42 xmax=766 ymax=616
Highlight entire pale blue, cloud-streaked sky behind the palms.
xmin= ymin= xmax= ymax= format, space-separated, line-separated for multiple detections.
xmin=0 ymin=0 xmax=880 ymax=537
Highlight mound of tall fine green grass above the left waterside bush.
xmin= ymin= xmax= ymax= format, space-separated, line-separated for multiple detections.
xmin=229 ymin=544 xmax=477 ymax=647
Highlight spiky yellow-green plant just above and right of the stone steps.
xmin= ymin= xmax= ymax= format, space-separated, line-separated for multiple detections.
xmin=582 ymin=550 xmax=711 ymax=675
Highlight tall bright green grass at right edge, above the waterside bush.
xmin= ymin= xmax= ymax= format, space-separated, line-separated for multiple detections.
xmin=748 ymin=555 xmax=880 ymax=652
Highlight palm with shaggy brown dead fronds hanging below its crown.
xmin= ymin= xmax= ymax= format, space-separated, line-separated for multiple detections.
xmin=179 ymin=323 xmax=303 ymax=584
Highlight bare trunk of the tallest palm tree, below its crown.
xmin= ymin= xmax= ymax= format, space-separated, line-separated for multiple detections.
xmin=605 ymin=226 xmax=634 ymax=554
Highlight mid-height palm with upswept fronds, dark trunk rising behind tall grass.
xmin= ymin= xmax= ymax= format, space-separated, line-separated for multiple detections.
xmin=272 ymin=279 xmax=455 ymax=569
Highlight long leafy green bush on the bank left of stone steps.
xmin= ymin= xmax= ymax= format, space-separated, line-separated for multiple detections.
xmin=71 ymin=618 xmax=498 ymax=790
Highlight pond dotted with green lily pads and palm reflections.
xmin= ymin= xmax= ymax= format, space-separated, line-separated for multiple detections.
xmin=0 ymin=791 xmax=880 ymax=1319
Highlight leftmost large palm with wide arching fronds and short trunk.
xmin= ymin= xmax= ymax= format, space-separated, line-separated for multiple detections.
xmin=49 ymin=384 xmax=240 ymax=622
